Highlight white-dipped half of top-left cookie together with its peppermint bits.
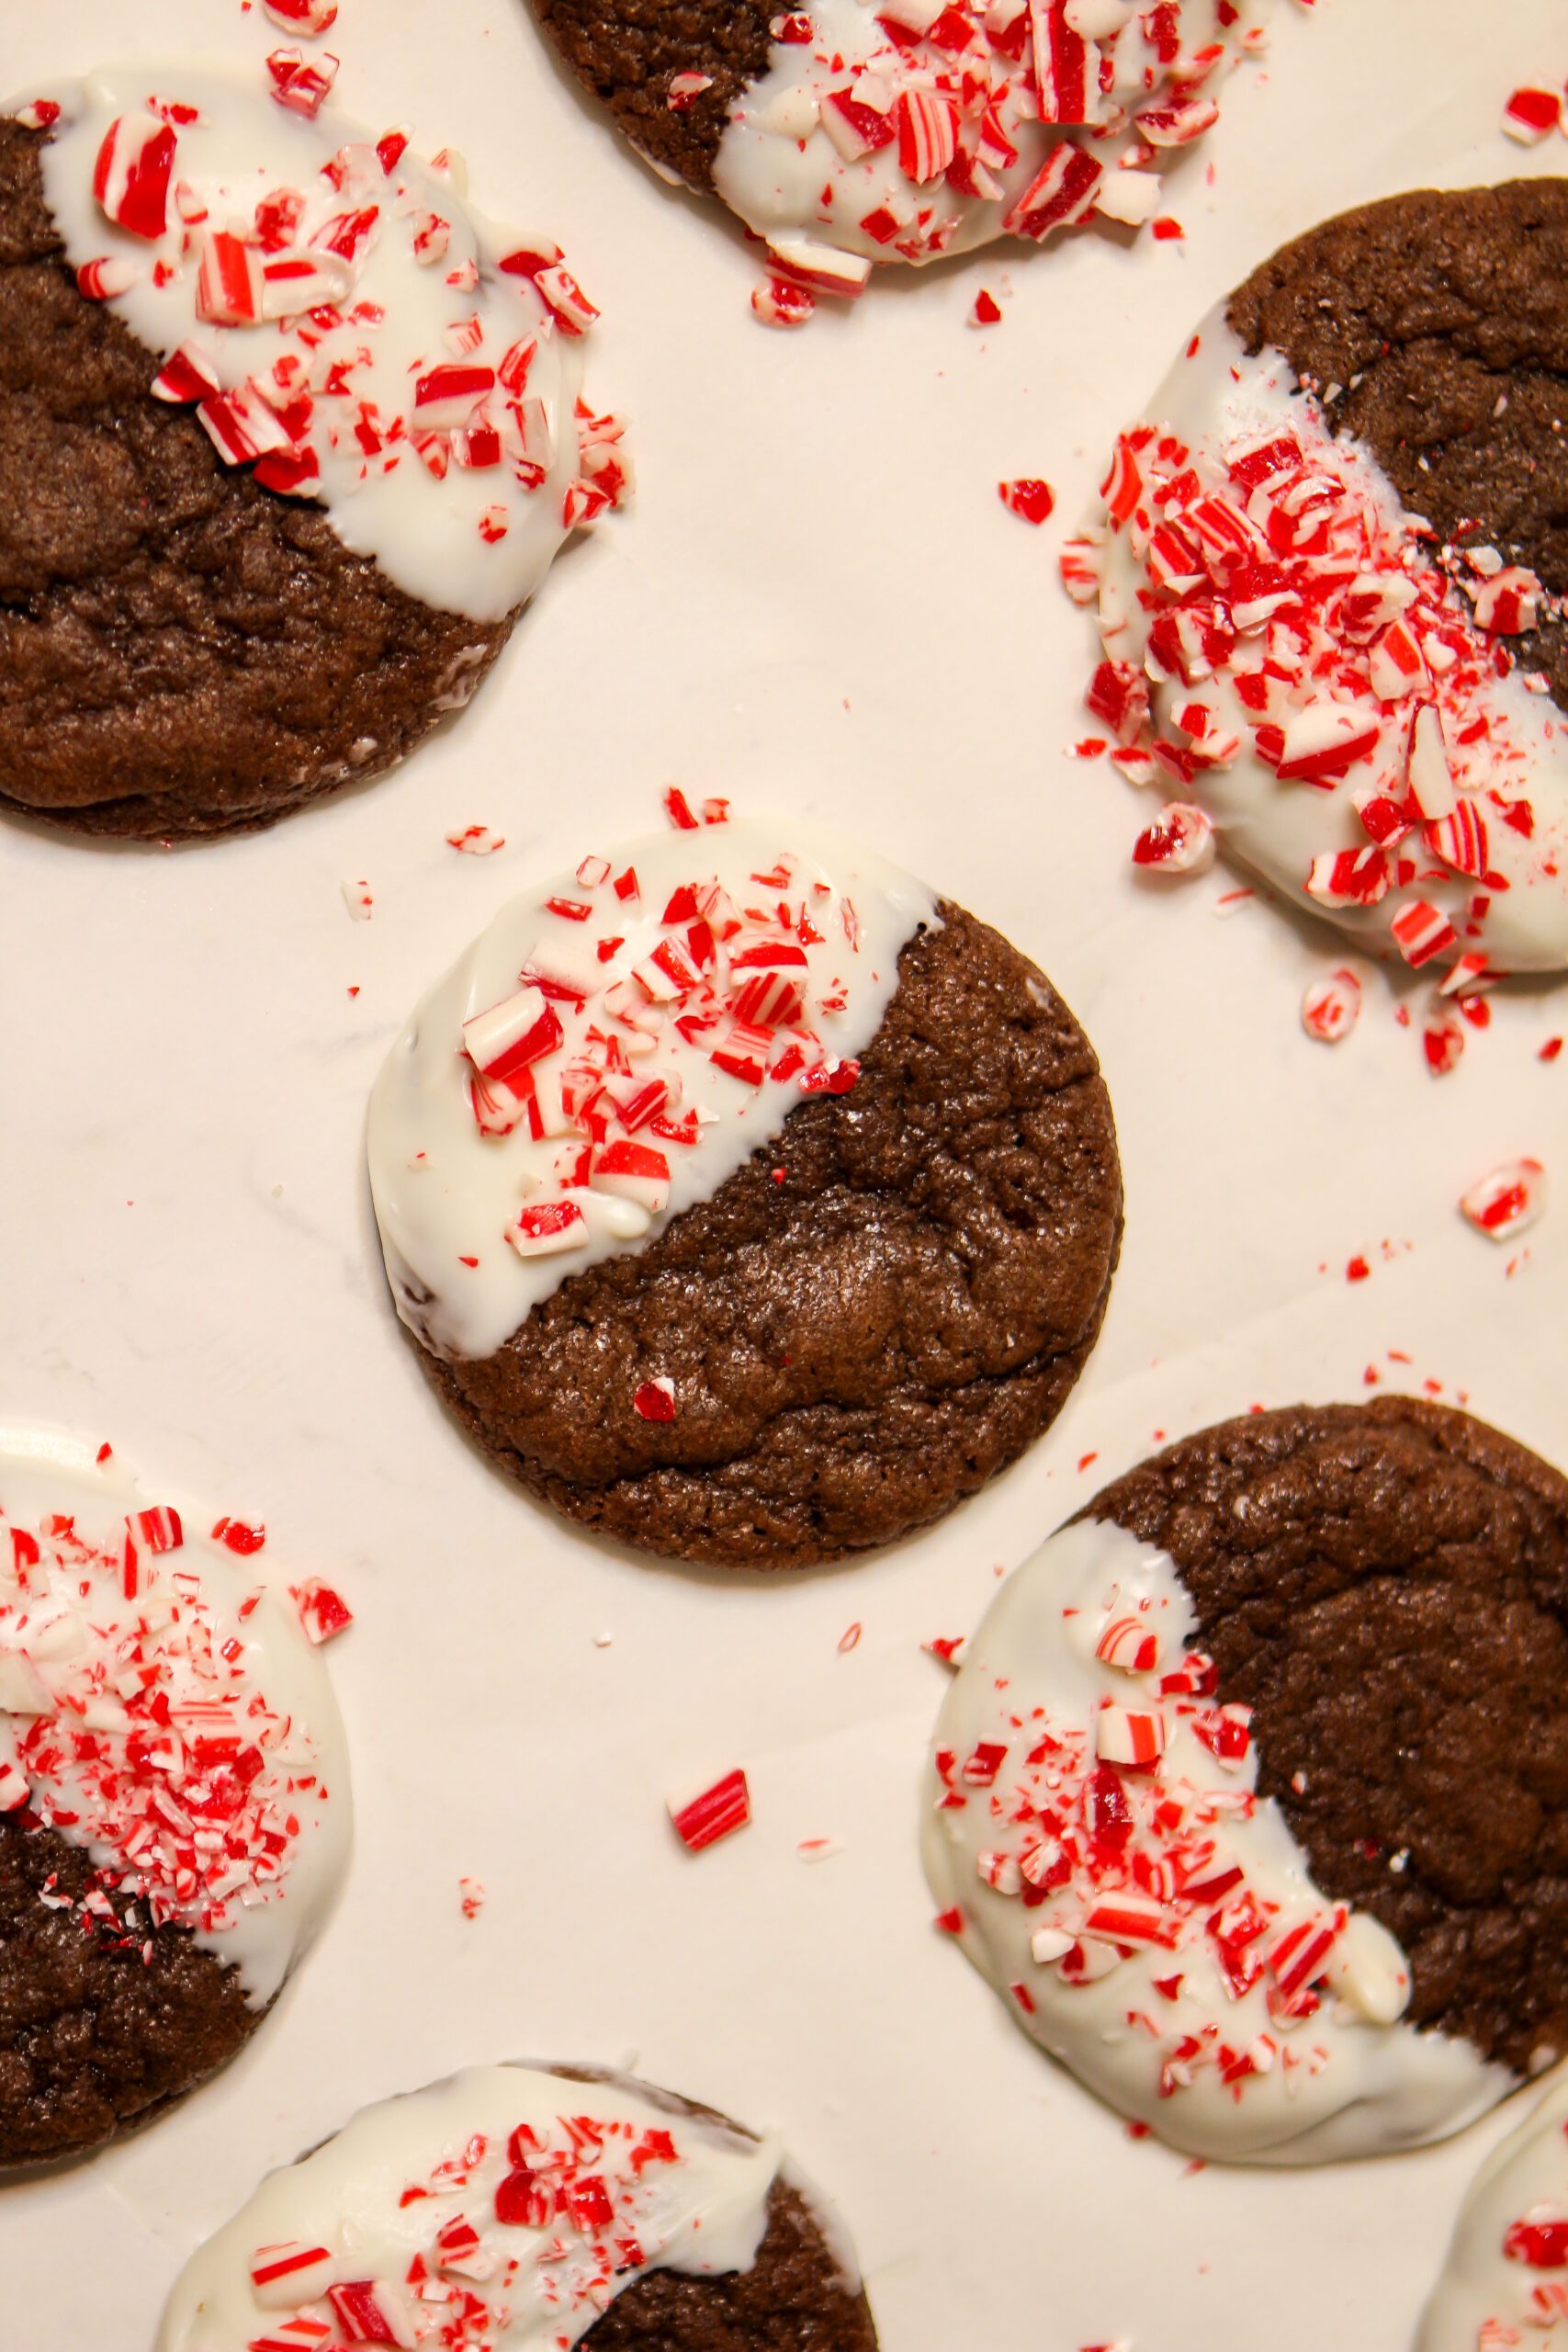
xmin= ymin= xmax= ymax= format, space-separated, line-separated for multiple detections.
xmin=41 ymin=70 xmax=630 ymax=620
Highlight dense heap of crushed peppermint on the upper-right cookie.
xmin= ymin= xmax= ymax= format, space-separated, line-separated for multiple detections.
xmin=1063 ymin=395 xmax=1554 ymax=973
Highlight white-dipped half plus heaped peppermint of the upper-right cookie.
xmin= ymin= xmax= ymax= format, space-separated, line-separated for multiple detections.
xmin=1086 ymin=320 xmax=1568 ymax=992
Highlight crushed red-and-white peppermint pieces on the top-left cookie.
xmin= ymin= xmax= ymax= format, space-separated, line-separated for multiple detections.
xmin=21 ymin=85 xmax=630 ymax=546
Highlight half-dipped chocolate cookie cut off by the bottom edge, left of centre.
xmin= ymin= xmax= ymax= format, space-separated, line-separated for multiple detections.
xmin=155 ymin=2065 xmax=877 ymax=2352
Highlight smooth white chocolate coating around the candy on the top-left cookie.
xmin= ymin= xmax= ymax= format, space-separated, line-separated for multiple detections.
xmin=28 ymin=62 xmax=606 ymax=621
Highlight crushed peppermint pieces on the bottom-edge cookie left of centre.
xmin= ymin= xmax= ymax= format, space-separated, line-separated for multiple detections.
xmin=247 ymin=2114 xmax=684 ymax=2352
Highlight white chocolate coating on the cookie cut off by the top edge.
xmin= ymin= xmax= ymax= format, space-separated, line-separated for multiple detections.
xmin=712 ymin=0 xmax=1256 ymax=275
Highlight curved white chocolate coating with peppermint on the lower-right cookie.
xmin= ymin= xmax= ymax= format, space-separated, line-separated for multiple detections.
xmin=921 ymin=1521 xmax=1512 ymax=2164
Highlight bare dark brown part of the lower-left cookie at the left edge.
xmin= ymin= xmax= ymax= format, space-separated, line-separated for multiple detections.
xmin=0 ymin=1814 xmax=261 ymax=2168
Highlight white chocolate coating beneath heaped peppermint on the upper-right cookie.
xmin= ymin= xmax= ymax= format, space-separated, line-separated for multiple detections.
xmin=1100 ymin=308 xmax=1568 ymax=971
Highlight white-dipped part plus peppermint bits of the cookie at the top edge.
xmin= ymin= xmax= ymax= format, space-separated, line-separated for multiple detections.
xmin=724 ymin=0 xmax=1253 ymax=308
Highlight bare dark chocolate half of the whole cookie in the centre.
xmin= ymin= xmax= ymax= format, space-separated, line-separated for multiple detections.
xmin=428 ymin=906 xmax=1122 ymax=1566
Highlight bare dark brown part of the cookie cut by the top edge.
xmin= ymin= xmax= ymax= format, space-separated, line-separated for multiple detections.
xmin=534 ymin=0 xmax=778 ymax=190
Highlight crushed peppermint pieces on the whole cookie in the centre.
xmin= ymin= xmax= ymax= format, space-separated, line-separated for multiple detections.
xmin=461 ymin=813 xmax=861 ymax=1288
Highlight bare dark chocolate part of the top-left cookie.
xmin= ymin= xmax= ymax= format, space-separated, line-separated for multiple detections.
xmin=0 ymin=120 xmax=510 ymax=840
